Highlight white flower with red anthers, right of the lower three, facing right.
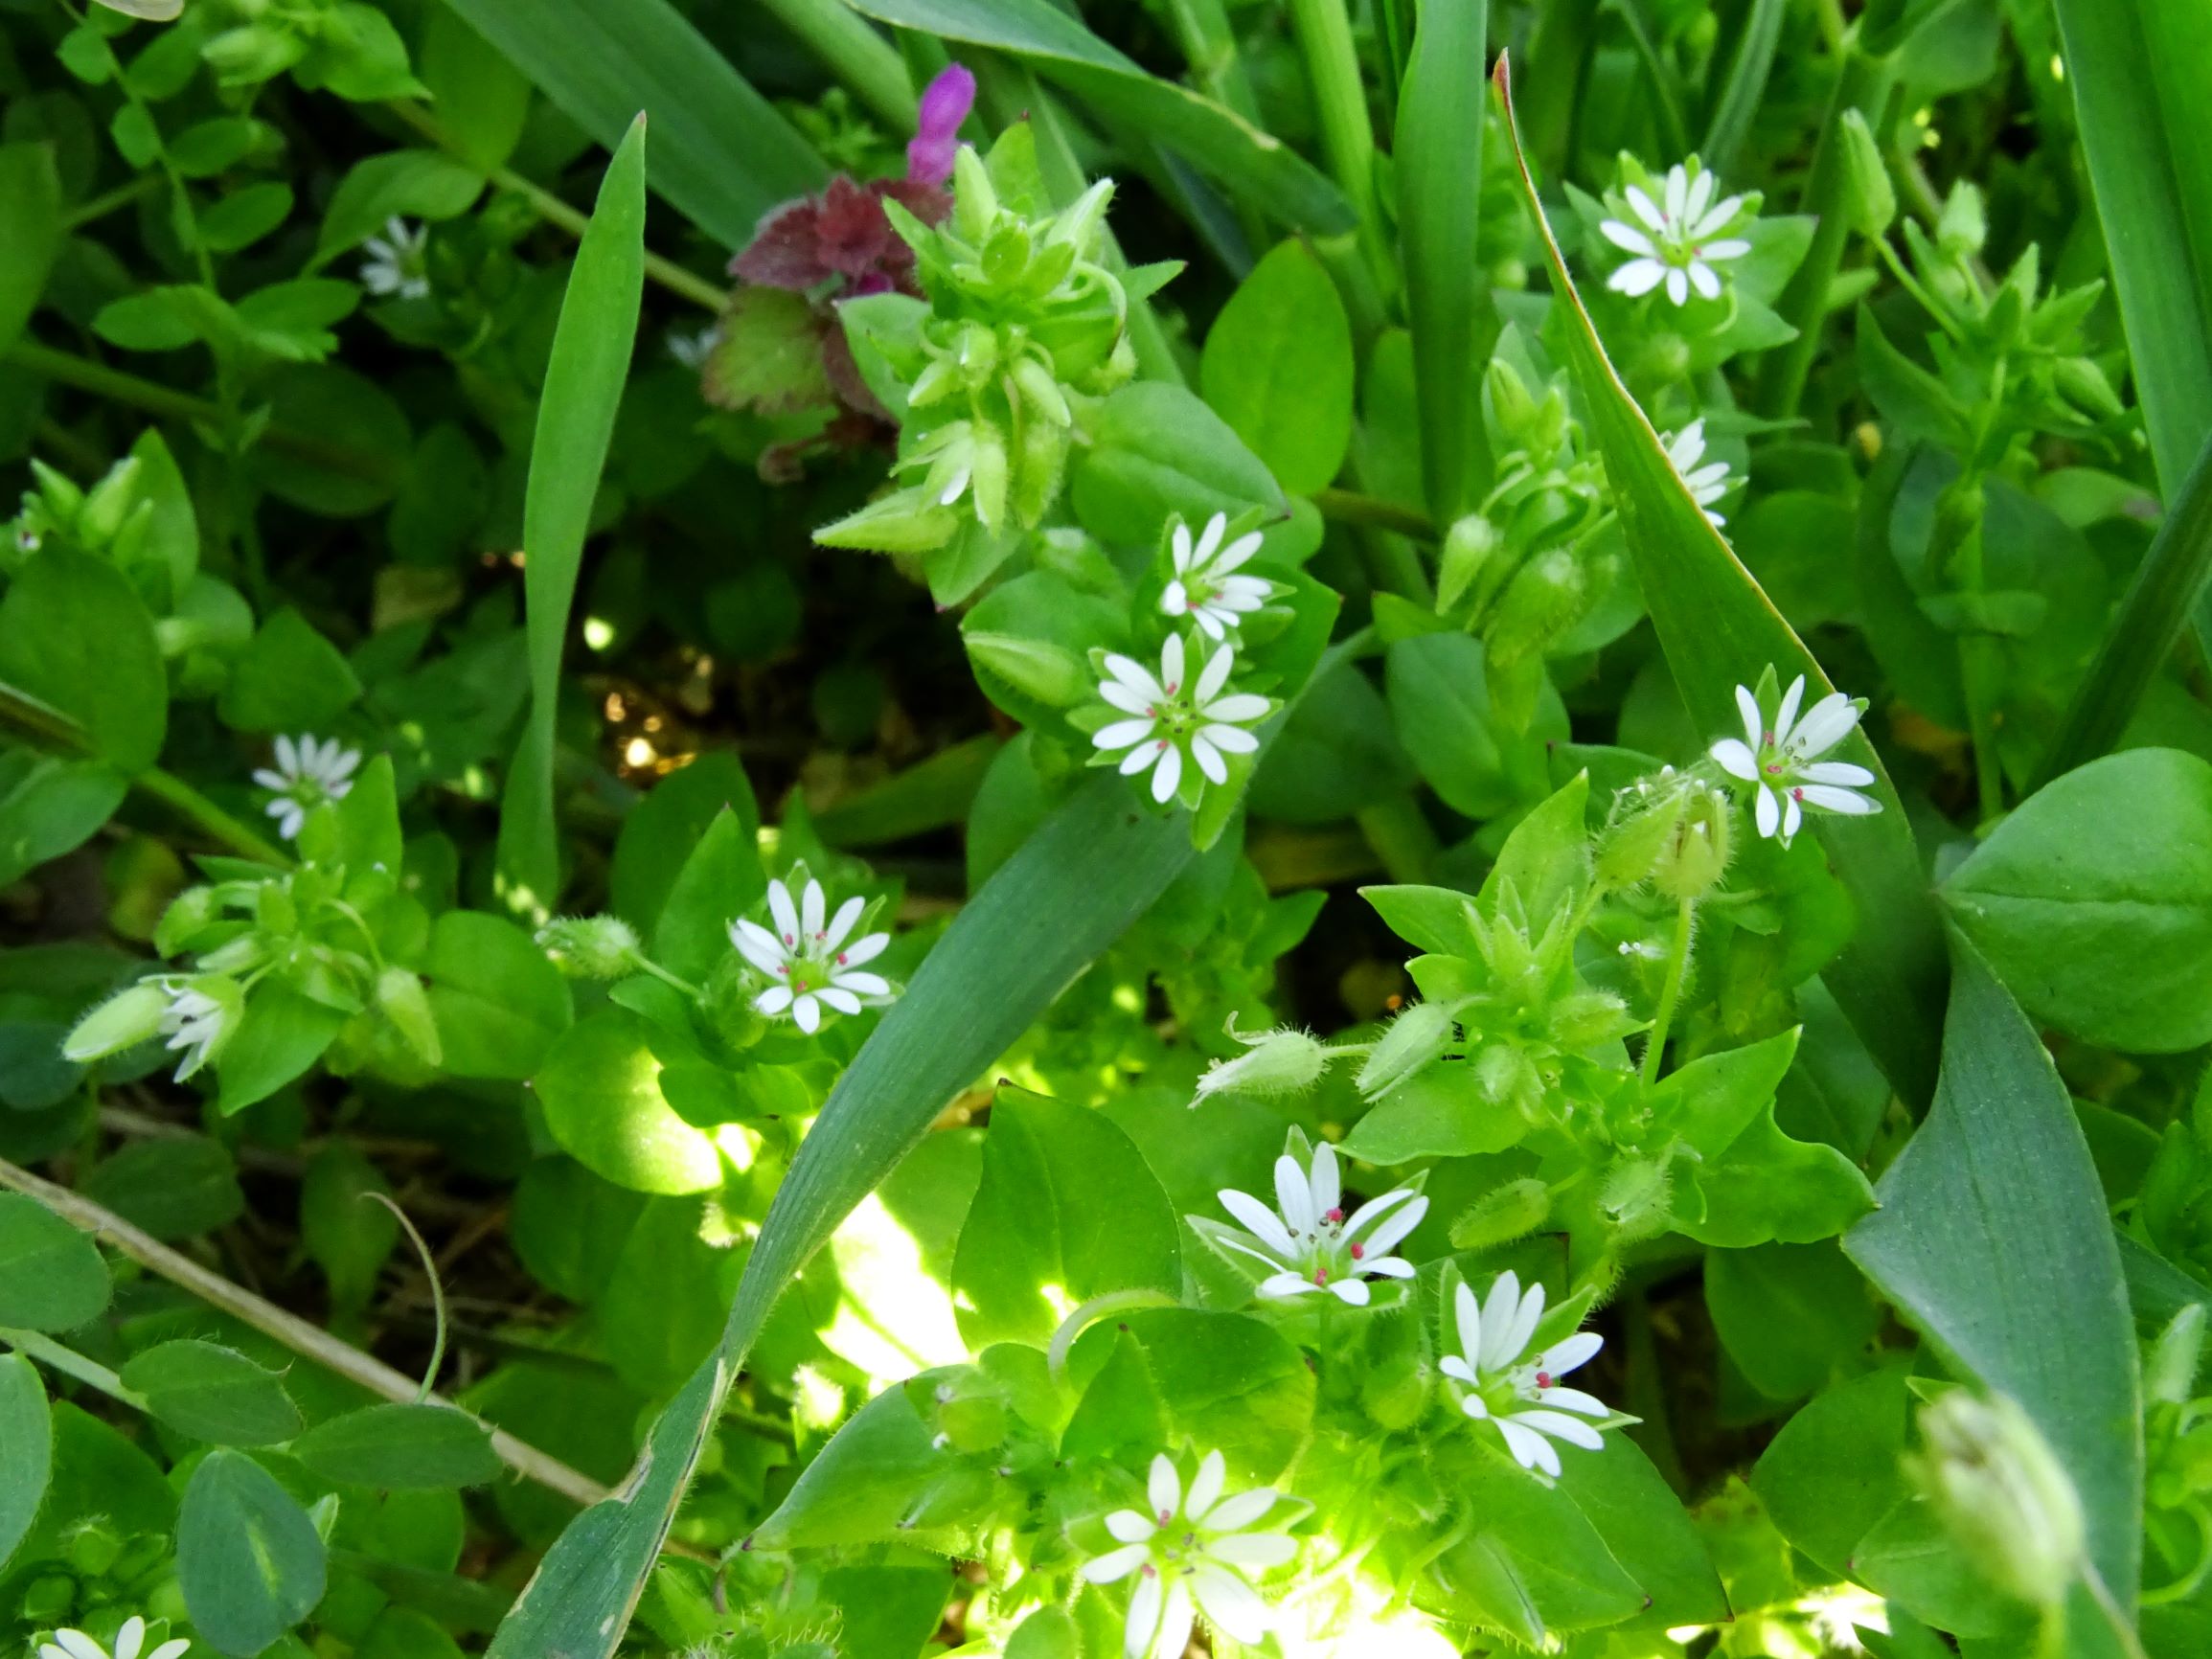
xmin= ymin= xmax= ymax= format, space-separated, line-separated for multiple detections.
xmin=1438 ymin=1272 xmax=1612 ymax=1475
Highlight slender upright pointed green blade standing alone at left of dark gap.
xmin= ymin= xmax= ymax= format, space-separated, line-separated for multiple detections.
xmin=495 ymin=117 xmax=646 ymax=914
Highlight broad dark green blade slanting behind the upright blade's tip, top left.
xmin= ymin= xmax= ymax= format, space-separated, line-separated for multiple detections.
xmin=431 ymin=0 xmax=830 ymax=249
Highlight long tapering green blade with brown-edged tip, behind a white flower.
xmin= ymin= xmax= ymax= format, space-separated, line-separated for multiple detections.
xmin=1497 ymin=57 xmax=1945 ymax=1106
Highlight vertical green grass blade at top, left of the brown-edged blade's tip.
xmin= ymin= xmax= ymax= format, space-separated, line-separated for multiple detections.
xmin=1391 ymin=0 xmax=1491 ymax=524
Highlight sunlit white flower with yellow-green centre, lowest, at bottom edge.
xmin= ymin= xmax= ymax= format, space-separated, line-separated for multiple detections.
xmin=1082 ymin=1451 xmax=1298 ymax=1659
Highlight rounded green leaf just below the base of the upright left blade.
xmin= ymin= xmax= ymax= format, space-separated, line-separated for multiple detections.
xmin=422 ymin=909 xmax=571 ymax=1078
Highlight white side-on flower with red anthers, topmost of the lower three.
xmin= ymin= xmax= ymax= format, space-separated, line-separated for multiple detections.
xmin=1210 ymin=1142 xmax=1429 ymax=1307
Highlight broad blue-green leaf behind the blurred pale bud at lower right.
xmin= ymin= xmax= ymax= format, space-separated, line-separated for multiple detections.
xmin=1842 ymin=940 xmax=2143 ymax=1606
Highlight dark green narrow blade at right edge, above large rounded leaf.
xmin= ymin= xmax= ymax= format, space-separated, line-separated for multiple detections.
xmin=2035 ymin=431 xmax=2212 ymax=789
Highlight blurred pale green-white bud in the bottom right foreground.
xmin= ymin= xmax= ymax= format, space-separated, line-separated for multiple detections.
xmin=1906 ymin=1389 xmax=2084 ymax=1606
